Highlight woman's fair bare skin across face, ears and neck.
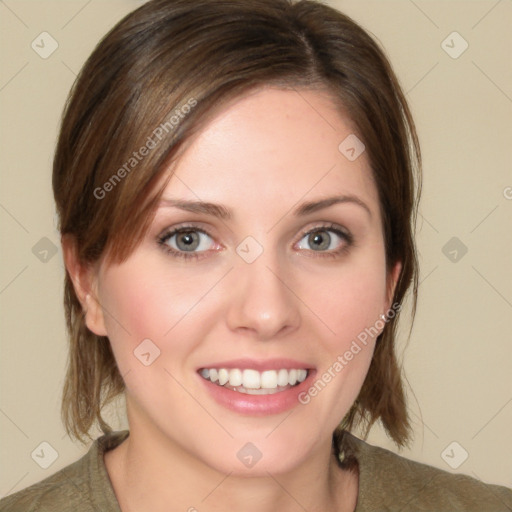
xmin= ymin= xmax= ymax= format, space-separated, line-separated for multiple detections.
xmin=63 ymin=88 xmax=401 ymax=512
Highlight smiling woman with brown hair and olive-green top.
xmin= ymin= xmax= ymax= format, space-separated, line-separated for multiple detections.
xmin=0 ymin=0 xmax=512 ymax=512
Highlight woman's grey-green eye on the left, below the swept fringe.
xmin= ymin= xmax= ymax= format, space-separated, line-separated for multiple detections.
xmin=158 ymin=226 xmax=215 ymax=258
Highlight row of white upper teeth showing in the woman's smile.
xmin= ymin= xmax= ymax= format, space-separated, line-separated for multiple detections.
xmin=200 ymin=368 xmax=308 ymax=395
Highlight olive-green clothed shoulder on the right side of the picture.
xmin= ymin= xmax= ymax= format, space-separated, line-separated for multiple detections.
xmin=343 ymin=433 xmax=512 ymax=512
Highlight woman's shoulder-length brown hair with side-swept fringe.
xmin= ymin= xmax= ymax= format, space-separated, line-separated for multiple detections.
xmin=53 ymin=0 xmax=421 ymax=445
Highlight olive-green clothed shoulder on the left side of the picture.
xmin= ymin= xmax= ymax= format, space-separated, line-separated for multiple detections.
xmin=0 ymin=431 xmax=128 ymax=512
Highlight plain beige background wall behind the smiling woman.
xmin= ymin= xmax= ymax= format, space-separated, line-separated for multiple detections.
xmin=0 ymin=0 xmax=512 ymax=496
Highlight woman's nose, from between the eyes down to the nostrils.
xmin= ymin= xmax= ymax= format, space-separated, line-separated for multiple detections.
xmin=227 ymin=251 xmax=301 ymax=341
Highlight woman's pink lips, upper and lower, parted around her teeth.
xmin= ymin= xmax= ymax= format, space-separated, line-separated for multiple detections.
xmin=197 ymin=360 xmax=316 ymax=416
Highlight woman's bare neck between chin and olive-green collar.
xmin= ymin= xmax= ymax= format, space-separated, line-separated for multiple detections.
xmin=105 ymin=418 xmax=358 ymax=512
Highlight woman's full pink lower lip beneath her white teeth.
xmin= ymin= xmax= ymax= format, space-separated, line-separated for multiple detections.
xmin=198 ymin=370 xmax=316 ymax=416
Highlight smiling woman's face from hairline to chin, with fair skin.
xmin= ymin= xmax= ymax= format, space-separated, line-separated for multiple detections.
xmin=83 ymin=89 xmax=399 ymax=475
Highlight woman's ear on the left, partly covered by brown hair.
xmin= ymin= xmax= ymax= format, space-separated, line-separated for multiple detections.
xmin=61 ymin=235 xmax=107 ymax=336
